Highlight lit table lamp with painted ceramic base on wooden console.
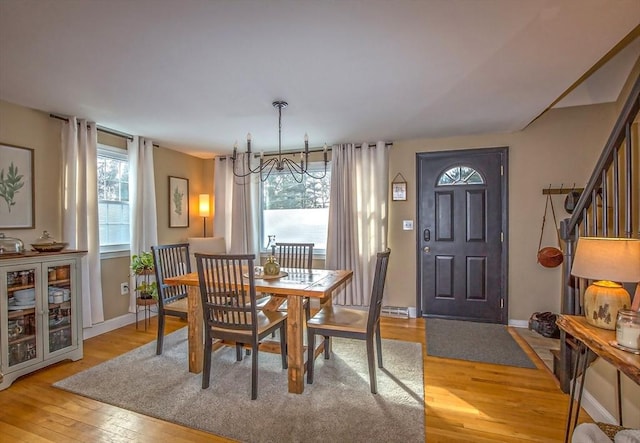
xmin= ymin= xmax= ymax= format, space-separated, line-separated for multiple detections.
xmin=571 ymin=237 xmax=640 ymax=330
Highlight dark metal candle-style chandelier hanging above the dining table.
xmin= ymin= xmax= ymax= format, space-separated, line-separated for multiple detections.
xmin=231 ymin=100 xmax=327 ymax=183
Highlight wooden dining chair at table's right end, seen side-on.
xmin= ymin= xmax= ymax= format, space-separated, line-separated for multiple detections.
xmin=307 ymin=249 xmax=391 ymax=394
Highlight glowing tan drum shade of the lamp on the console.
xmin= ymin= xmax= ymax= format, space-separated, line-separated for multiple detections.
xmin=571 ymin=237 xmax=640 ymax=283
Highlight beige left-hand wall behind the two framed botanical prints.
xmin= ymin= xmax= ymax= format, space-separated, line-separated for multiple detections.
xmin=0 ymin=101 xmax=213 ymax=320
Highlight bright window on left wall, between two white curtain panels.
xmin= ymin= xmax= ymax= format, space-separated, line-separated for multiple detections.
xmin=98 ymin=145 xmax=130 ymax=252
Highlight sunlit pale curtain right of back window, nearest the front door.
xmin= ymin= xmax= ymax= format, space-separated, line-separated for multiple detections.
xmin=326 ymin=142 xmax=389 ymax=306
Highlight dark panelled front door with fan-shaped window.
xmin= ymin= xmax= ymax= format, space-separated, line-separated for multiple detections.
xmin=416 ymin=148 xmax=508 ymax=323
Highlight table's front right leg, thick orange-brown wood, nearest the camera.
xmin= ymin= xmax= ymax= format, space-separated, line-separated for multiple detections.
xmin=287 ymin=295 xmax=304 ymax=394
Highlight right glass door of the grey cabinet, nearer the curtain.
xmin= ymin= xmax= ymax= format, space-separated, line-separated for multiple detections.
xmin=45 ymin=263 xmax=75 ymax=353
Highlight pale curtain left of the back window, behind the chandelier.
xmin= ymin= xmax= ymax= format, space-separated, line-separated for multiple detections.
xmin=213 ymin=154 xmax=260 ymax=253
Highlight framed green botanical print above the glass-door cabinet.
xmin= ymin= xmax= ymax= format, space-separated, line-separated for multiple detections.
xmin=0 ymin=144 xmax=35 ymax=229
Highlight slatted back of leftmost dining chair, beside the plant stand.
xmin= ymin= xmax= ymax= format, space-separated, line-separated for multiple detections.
xmin=151 ymin=243 xmax=191 ymax=309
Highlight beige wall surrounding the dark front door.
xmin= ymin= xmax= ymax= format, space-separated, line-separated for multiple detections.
xmin=385 ymin=104 xmax=616 ymax=320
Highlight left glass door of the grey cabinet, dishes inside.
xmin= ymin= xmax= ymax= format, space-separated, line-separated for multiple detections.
xmin=3 ymin=265 xmax=40 ymax=367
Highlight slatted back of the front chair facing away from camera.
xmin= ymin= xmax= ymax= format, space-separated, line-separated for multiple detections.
xmin=195 ymin=253 xmax=257 ymax=331
